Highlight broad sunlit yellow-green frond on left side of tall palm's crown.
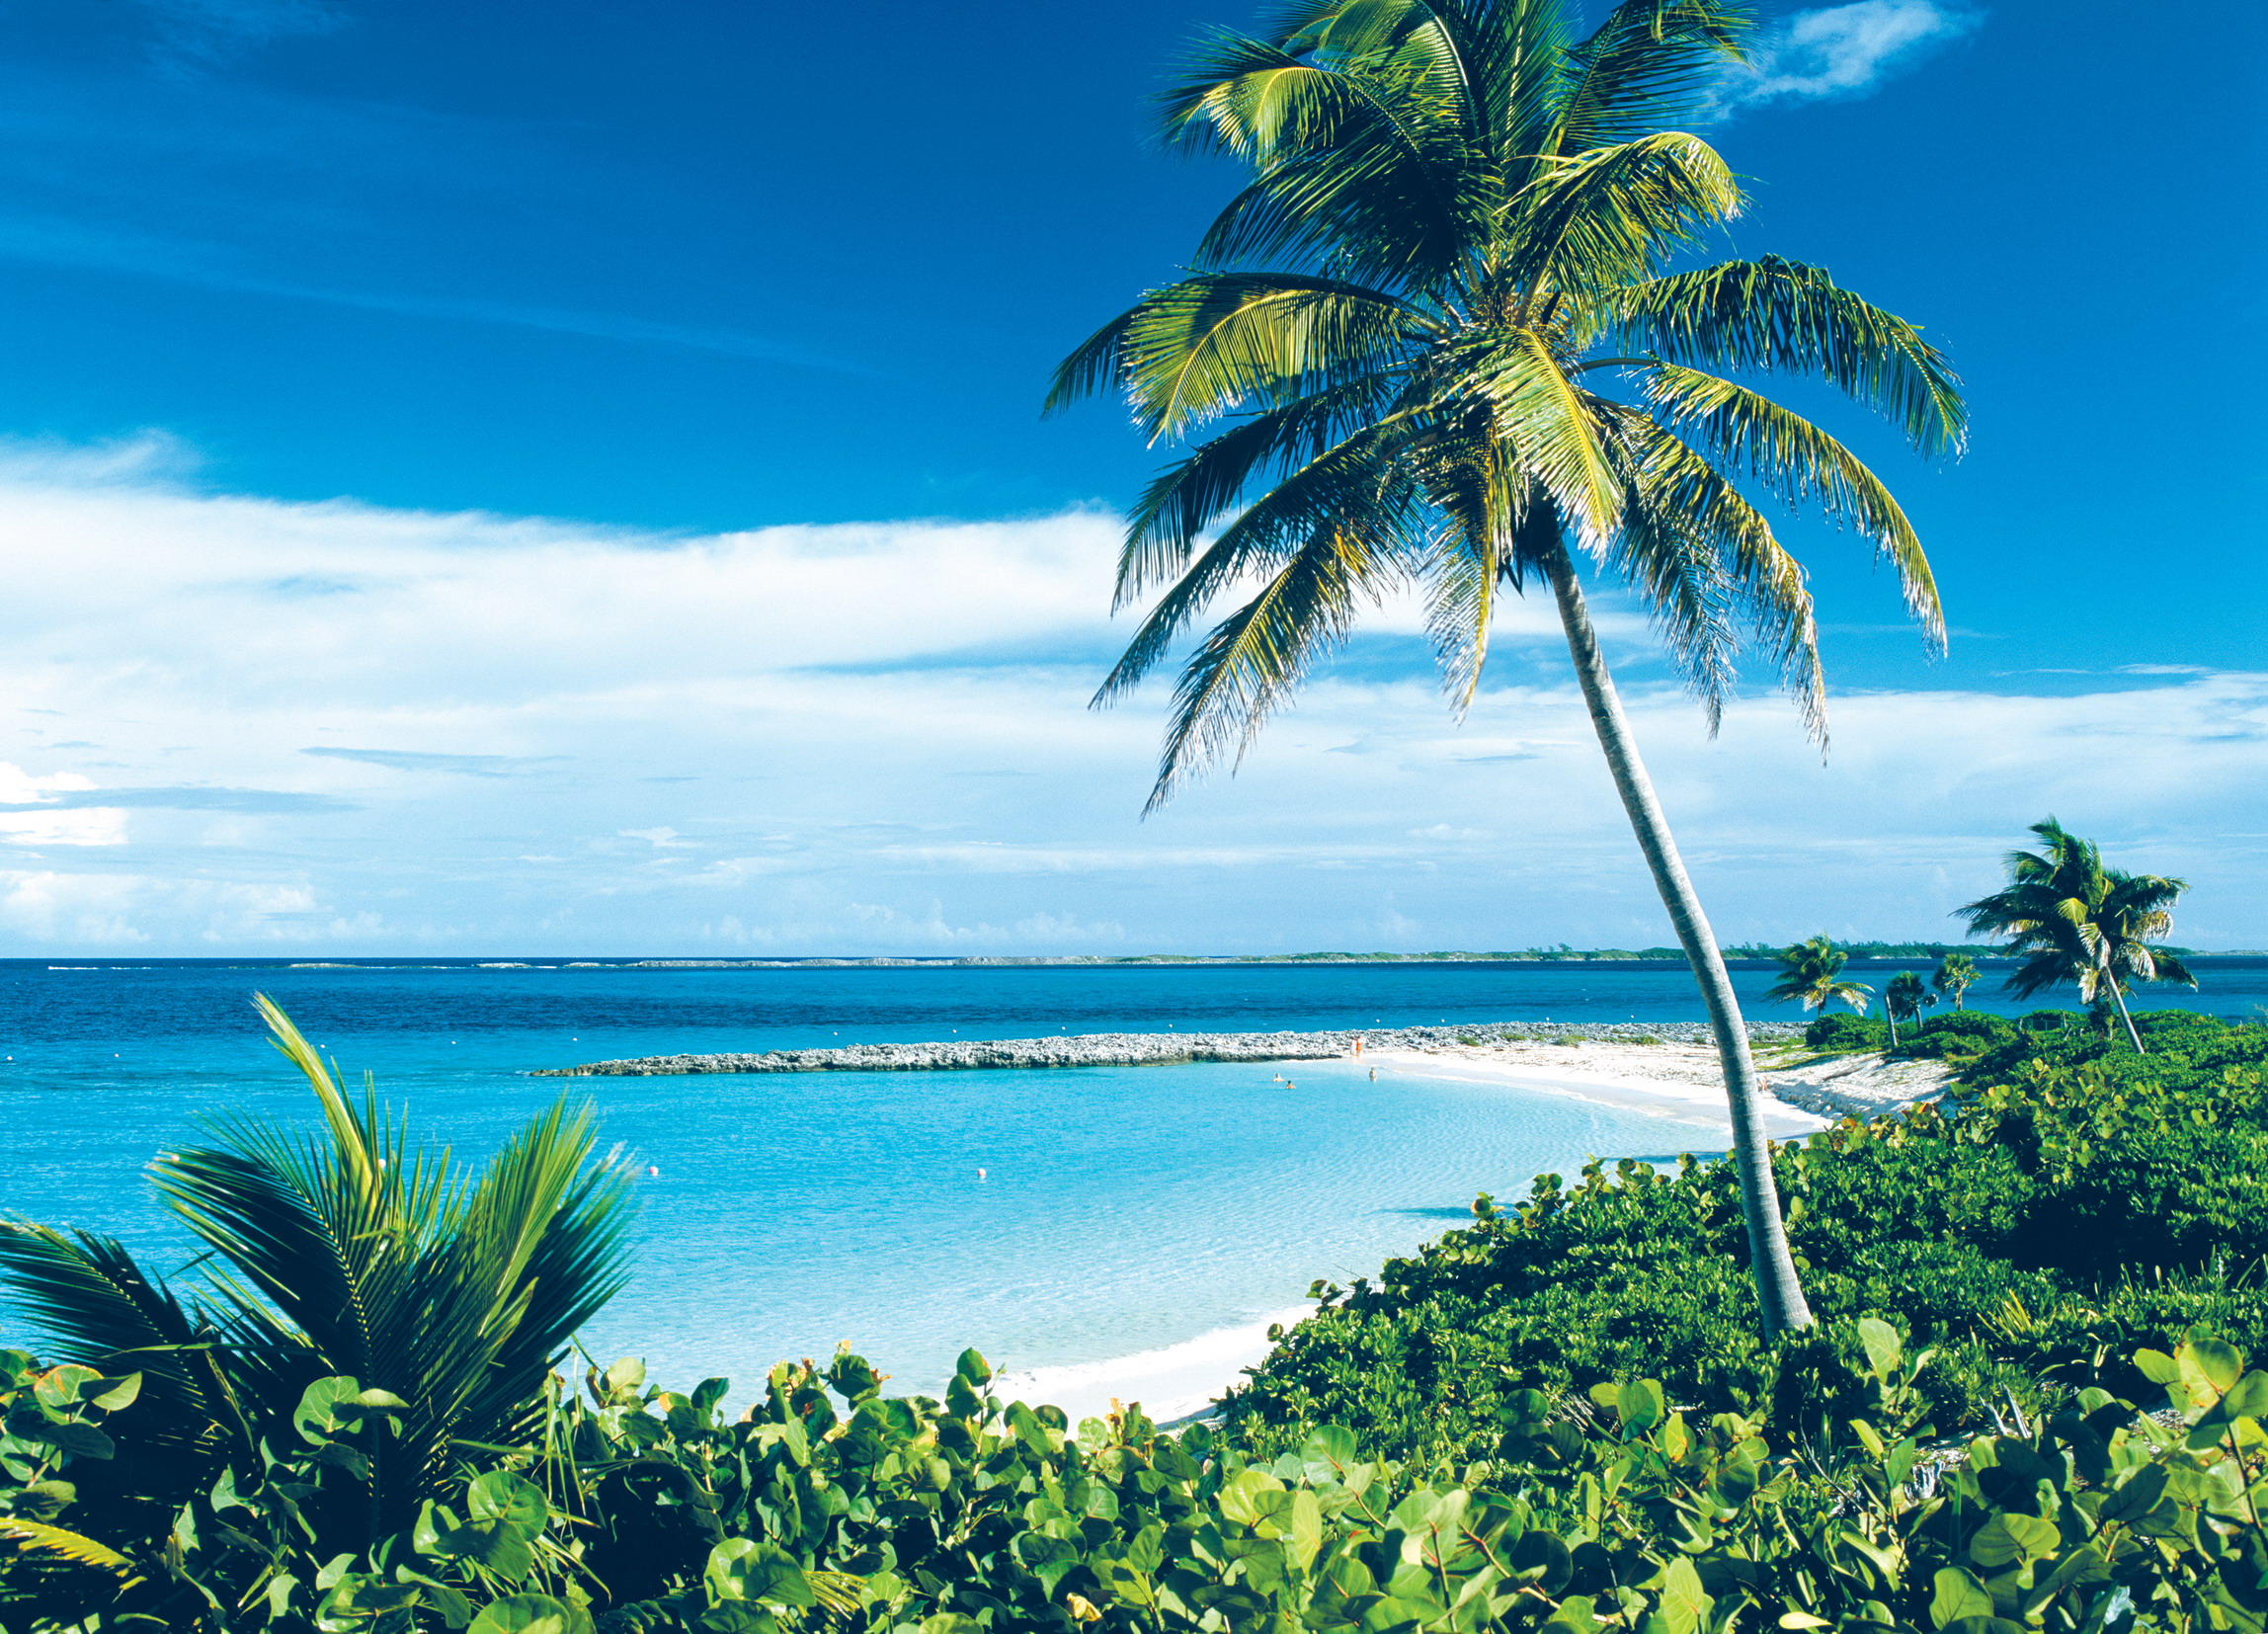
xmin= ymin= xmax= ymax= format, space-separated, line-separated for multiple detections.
xmin=1118 ymin=273 xmax=1431 ymax=443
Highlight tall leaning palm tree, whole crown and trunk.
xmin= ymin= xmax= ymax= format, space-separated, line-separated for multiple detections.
xmin=1050 ymin=0 xmax=1962 ymax=1330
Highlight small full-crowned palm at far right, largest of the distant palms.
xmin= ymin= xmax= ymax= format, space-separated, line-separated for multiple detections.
xmin=1955 ymin=817 xmax=2198 ymax=1055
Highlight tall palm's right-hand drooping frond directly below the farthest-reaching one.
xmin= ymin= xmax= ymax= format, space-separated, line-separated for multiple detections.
xmin=1645 ymin=364 xmax=1946 ymax=651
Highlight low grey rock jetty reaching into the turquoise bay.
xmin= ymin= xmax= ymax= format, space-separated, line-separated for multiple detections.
xmin=535 ymin=1021 xmax=1803 ymax=1078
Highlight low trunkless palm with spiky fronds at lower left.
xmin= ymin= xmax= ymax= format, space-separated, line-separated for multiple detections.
xmin=0 ymin=996 xmax=628 ymax=1552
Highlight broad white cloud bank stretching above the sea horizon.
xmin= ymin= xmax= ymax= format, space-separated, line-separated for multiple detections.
xmin=0 ymin=443 xmax=2268 ymax=955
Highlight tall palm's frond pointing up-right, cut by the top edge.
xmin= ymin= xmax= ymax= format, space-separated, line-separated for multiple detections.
xmin=1549 ymin=0 xmax=1755 ymax=154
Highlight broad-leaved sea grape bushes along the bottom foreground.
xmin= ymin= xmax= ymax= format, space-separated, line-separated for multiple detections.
xmin=13 ymin=1319 xmax=2268 ymax=1634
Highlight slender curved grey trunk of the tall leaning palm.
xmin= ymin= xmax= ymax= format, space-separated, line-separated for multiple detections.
xmin=1542 ymin=544 xmax=1813 ymax=1335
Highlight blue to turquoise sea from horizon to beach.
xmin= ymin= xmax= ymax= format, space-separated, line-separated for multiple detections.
xmin=0 ymin=957 xmax=2268 ymax=1393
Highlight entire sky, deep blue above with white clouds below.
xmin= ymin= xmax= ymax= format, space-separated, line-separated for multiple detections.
xmin=0 ymin=0 xmax=2268 ymax=953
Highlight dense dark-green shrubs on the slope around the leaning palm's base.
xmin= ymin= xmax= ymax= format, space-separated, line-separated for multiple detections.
xmin=1229 ymin=1013 xmax=2268 ymax=1459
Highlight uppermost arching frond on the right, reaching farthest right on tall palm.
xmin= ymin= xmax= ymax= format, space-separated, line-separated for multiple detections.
xmin=1610 ymin=257 xmax=1969 ymax=453
